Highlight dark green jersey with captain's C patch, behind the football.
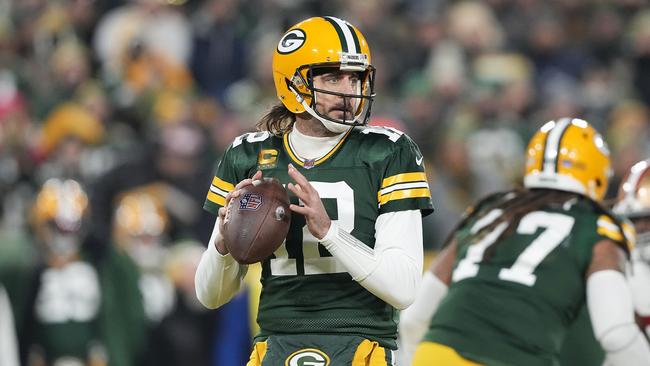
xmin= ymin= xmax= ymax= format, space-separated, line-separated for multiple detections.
xmin=204 ymin=127 xmax=432 ymax=349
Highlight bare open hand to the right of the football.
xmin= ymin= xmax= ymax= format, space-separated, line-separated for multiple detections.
xmin=287 ymin=164 xmax=332 ymax=240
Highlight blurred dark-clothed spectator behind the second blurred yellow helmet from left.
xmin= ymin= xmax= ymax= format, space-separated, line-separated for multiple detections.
xmin=91 ymin=122 xmax=211 ymax=255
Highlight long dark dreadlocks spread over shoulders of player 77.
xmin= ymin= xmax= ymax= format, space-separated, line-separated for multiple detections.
xmin=445 ymin=188 xmax=622 ymax=258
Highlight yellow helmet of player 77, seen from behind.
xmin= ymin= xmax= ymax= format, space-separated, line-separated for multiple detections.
xmin=524 ymin=118 xmax=611 ymax=202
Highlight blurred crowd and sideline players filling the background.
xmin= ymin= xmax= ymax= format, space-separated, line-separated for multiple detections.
xmin=0 ymin=0 xmax=650 ymax=365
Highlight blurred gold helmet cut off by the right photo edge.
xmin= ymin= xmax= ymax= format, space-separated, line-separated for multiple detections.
xmin=614 ymin=159 xmax=650 ymax=219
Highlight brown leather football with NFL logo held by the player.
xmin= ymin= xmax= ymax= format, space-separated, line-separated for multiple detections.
xmin=223 ymin=178 xmax=291 ymax=264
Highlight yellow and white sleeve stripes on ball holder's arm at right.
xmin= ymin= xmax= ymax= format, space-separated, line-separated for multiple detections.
xmin=377 ymin=172 xmax=431 ymax=210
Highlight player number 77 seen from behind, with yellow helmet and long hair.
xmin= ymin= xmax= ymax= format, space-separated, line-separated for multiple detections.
xmin=400 ymin=118 xmax=650 ymax=366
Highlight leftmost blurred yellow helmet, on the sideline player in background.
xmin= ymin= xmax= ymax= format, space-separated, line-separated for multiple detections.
xmin=31 ymin=178 xmax=88 ymax=232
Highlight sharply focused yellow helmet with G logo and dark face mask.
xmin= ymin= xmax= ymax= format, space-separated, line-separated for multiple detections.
xmin=273 ymin=16 xmax=375 ymax=126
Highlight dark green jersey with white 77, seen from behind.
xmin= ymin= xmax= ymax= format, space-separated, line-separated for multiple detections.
xmin=424 ymin=194 xmax=626 ymax=366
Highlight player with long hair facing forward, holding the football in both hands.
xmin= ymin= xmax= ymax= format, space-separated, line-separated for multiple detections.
xmin=195 ymin=17 xmax=433 ymax=366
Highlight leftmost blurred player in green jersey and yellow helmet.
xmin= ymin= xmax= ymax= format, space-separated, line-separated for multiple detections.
xmin=21 ymin=178 xmax=107 ymax=365
